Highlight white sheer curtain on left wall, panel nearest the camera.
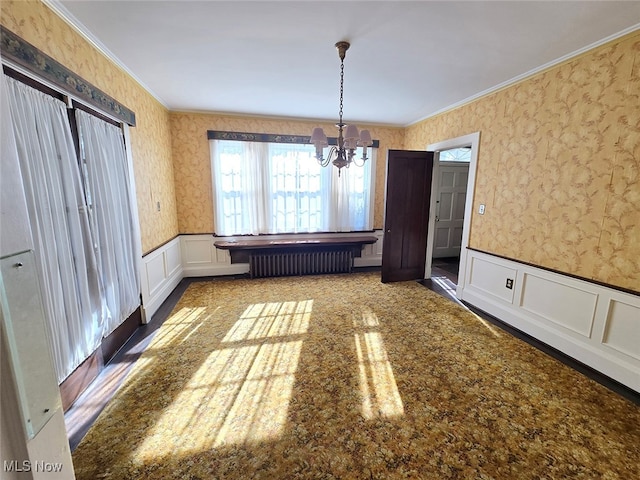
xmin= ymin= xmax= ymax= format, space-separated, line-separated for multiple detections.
xmin=3 ymin=75 xmax=106 ymax=382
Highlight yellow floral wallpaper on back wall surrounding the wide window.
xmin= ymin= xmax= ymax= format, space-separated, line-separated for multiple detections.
xmin=170 ymin=112 xmax=404 ymax=233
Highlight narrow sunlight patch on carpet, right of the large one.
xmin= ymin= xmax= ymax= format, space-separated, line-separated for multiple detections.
xmin=354 ymin=311 xmax=404 ymax=420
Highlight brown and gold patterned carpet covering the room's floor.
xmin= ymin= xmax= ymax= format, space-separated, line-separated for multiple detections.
xmin=73 ymin=273 xmax=640 ymax=480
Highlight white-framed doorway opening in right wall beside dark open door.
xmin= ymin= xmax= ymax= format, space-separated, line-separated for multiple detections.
xmin=425 ymin=132 xmax=480 ymax=298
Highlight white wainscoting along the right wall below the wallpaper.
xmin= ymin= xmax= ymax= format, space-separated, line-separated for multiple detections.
xmin=461 ymin=249 xmax=640 ymax=392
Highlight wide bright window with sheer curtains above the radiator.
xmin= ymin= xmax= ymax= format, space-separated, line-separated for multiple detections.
xmin=210 ymin=140 xmax=375 ymax=235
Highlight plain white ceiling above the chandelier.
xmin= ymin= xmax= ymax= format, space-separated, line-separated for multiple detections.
xmin=47 ymin=0 xmax=640 ymax=125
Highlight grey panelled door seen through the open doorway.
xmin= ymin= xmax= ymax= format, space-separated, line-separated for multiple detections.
xmin=432 ymin=162 xmax=469 ymax=258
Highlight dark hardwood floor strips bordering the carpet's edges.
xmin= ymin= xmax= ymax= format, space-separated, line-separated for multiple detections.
xmin=65 ymin=266 xmax=640 ymax=451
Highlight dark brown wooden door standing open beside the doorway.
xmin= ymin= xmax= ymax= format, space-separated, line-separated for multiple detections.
xmin=382 ymin=150 xmax=433 ymax=283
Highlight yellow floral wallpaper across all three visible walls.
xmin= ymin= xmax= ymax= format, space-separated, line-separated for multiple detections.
xmin=0 ymin=0 xmax=640 ymax=291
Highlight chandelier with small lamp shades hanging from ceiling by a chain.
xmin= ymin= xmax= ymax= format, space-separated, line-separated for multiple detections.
xmin=310 ymin=42 xmax=373 ymax=176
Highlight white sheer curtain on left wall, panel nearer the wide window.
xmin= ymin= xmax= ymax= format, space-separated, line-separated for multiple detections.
xmin=76 ymin=110 xmax=142 ymax=336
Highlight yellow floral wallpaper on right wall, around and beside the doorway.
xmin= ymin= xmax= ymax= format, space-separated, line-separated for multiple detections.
xmin=405 ymin=31 xmax=640 ymax=292
